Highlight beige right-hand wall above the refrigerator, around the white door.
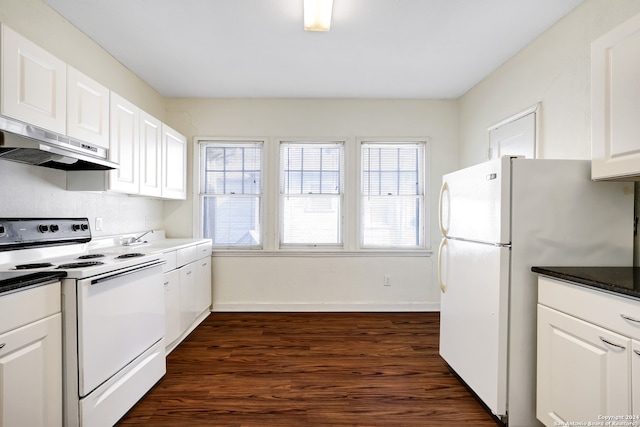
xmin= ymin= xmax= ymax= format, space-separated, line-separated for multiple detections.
xmin=459 ymin=0 xmax=640 ymax=167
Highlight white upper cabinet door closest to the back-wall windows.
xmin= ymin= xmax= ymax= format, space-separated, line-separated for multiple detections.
xmin=162 ymin=124 xmax=187 ymax=200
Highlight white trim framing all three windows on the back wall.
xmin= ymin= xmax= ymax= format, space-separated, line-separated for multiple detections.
xmin=191 ymin=137 xmax=430 ymax=257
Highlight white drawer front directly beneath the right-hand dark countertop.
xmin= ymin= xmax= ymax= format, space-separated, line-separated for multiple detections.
xmin=538 ymin=277 xmax=640 ymax=340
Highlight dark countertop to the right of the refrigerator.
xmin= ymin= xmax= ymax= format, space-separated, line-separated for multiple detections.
xmin=531 ymin=267 xmax=640 ymax=299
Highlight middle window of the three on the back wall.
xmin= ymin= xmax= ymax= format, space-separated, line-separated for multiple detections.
xmin=280 ymin=142 xmax=344 ymax=247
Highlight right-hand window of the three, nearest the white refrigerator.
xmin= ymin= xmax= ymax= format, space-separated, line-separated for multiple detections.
xmin=360 ymin=142 xmax=425 ymax=249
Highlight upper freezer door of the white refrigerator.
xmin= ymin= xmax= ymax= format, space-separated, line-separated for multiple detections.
xmin=440 ymin=157 xmax=511 ymax=244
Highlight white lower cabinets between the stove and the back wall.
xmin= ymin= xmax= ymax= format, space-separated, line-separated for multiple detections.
xmin=164 ymin=242 xmax=212 ymax=353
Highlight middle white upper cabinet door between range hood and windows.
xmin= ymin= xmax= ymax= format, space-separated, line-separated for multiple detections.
xmin=140 ymin=111 xmax=162 ymax=197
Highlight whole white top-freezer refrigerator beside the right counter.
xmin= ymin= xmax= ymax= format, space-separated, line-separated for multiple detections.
xmin=438 ymin=157 xmax=634 ymax=427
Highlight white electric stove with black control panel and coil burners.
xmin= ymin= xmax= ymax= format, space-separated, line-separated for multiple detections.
xmin=0 ymin=218 xmax=166 ymax=427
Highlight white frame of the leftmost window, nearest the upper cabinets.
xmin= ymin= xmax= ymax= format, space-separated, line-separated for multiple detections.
xmin=194 ymin=137 xmax=268 ymax=251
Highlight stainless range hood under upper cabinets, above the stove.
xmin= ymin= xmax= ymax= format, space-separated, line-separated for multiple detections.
xmin=0 ymin=116 xmax=118 ymax=170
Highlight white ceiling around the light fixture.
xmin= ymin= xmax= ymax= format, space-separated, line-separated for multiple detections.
xmin=44 ymin=0 xmax=582 ymax=98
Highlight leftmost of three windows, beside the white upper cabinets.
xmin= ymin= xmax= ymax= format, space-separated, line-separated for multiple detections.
xmin=200 ymin=141 xmax=263 ymax=248
